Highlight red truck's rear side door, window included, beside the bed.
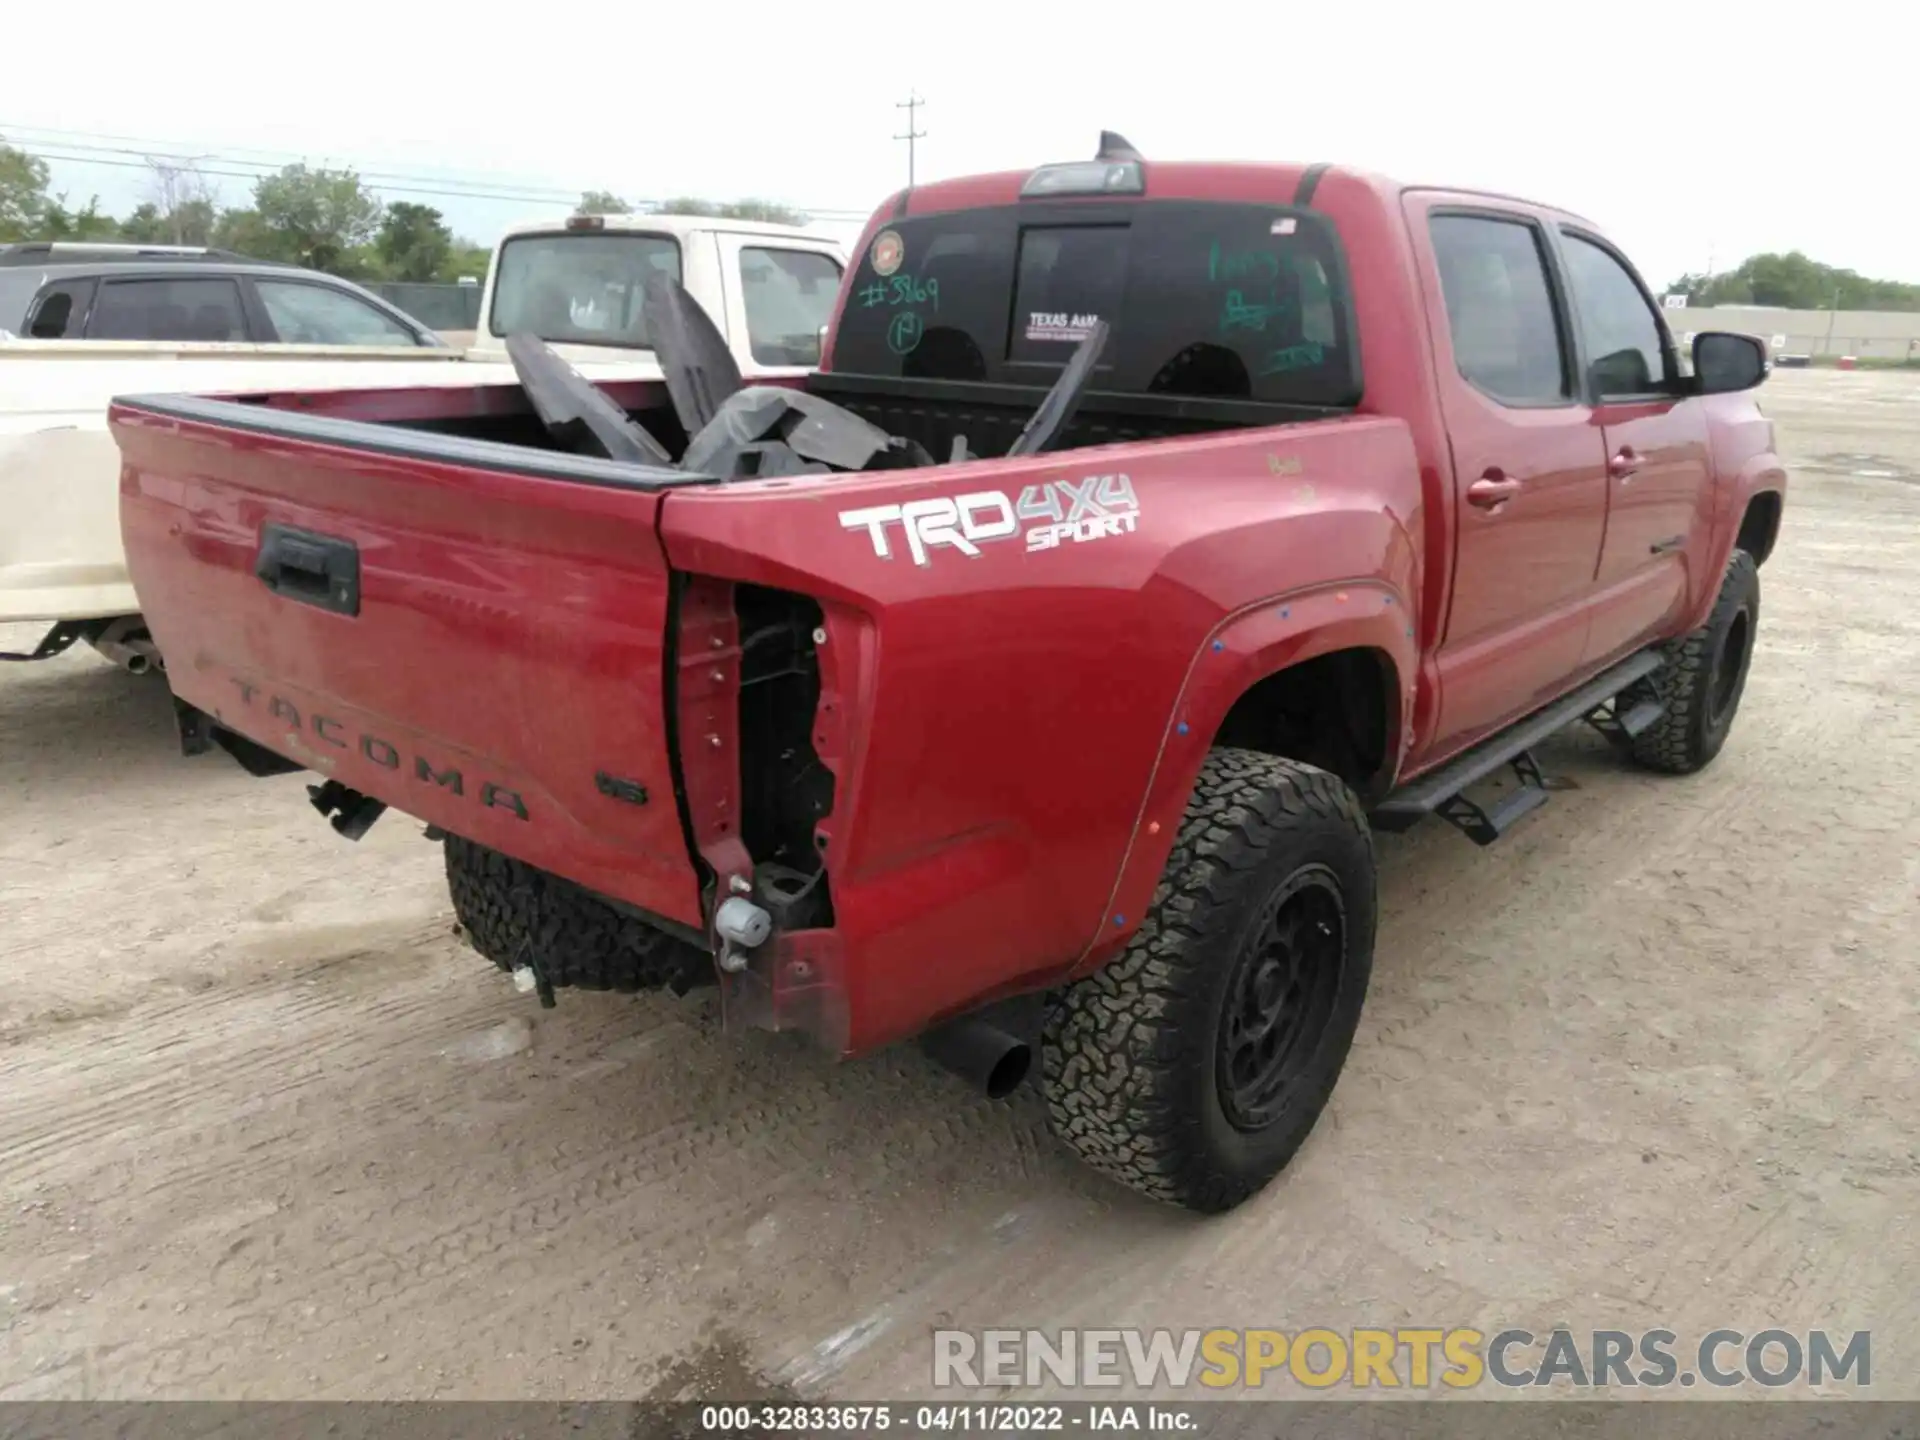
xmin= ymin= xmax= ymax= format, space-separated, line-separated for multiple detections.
xmin=1407 ymin=194 xmax=1607 ymax=751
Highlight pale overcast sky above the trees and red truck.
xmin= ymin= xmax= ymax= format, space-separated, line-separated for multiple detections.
xmin=0 ymin=0 xmax=1920 ymax=286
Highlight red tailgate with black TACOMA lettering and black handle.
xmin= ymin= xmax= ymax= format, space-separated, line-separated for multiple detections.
xmin=111 ymin=397 xmax=701 ymax=925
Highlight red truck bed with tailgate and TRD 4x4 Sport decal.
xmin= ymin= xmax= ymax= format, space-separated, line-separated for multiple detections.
xmin=111 ymin=366 xmax=1419 ymax=1052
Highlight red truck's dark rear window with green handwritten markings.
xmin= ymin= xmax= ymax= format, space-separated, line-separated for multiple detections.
xmin=833 ymin=200 xmax=1361 ymax=407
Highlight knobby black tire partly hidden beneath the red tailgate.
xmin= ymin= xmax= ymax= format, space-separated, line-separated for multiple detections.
xmin=445 ymin=835 xmax=710 ymax=995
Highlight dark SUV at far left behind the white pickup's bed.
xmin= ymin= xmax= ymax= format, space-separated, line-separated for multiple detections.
xmin=0 ymin=242 xmax=445 ymax=346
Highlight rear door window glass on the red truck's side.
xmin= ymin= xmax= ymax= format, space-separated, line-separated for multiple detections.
xmin=1432 ymin=215 xmax=1572 ymax=405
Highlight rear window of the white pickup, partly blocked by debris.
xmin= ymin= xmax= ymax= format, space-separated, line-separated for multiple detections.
xmin=488 ymin=230 xmax=682 ymax=349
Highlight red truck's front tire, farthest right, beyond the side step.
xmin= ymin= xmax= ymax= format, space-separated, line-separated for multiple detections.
xmin=1632 ymin=549 xmax=1761 ymax=776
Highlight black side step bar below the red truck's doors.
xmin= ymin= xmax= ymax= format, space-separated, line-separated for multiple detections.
xmin=1373 ymin=649 xmax=1667 ymax=845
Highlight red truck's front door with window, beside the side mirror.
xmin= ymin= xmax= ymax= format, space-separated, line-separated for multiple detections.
xmin=1559 ymin=227 xmax=1711 ymax=664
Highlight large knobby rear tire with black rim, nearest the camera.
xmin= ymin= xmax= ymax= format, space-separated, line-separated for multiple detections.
xmin=1043 ymin=749 xmax=1375 ymax=1213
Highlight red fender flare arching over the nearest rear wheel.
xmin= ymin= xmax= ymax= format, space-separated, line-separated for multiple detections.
xmin=1069 ymin=578 xmax=1419 ymax=977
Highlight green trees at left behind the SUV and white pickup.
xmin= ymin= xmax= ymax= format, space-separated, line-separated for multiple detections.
xmin=0 ymin=138 xmax=806 ymax=282
